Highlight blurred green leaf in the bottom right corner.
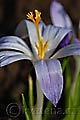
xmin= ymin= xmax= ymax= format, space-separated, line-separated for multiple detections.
xmin=63 ymin=70 xmax=80 ymax=120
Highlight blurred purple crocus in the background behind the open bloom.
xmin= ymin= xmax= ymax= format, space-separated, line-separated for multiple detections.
xmin=50 ymin=0 xmax=80 ymax=47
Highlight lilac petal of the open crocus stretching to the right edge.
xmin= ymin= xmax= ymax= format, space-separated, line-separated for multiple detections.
xmin=51 ymin=43 xmax=80 ymax=59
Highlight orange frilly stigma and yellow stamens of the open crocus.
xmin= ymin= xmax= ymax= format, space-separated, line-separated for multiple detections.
xmin=27 ymin=10 xmax=48 ymax=59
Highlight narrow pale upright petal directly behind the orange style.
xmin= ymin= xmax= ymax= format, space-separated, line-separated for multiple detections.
xmin=25 ymin=20 xmax=45 ymax=58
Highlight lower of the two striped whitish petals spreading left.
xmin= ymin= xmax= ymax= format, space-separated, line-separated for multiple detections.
xmin=0 ymin=51 xmax=30 ymax=67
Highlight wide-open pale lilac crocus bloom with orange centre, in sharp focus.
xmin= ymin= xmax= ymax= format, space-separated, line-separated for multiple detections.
xmin=0 ymin=10 xmax=80 ymax=106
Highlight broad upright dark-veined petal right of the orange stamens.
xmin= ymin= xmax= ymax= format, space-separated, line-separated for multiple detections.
xmin=43 ymin=25 xmax=71 ymax=57
